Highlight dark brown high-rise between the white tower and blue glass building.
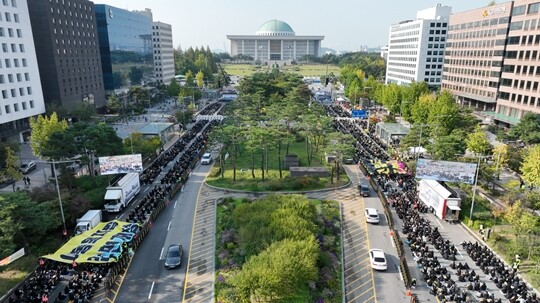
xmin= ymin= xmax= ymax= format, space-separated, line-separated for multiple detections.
xmin=28 ymin=0 xmax=106 ymax=109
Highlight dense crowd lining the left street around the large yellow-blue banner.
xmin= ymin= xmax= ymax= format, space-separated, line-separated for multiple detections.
xmin=8 ymin=103 xmax=221 ymax=303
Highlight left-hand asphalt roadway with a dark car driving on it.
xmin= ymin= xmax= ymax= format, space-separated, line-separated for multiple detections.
xmin=115 ymin=164 xmax=211 ymax=303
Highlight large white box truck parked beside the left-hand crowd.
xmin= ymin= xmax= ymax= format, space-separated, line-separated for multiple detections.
xmin=105 ymin=173 xmax=141 ymax=213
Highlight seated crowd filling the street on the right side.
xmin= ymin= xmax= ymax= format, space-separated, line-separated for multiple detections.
xmin=327 ymin=106 xmax=540 ymax=303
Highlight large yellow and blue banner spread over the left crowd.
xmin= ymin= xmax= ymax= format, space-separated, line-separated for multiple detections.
xmin=43 ymin=220 xmax=140 ymax=263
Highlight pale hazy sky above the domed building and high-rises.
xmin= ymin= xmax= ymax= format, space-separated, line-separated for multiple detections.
xmin=93 ymin=0 xmax=490 ymax=51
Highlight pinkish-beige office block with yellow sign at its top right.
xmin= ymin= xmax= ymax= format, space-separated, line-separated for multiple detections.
xmin=442 ymin=2 xmax=512 ymax=111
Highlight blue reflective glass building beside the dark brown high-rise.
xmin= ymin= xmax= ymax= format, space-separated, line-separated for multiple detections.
xmin=95 ymin=4 xmax=153 ymax=94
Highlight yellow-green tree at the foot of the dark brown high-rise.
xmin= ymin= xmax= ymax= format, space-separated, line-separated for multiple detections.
xmin=30 ymin=112 xmax=68 ymax=157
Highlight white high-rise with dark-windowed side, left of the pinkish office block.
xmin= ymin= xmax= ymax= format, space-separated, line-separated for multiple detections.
xmin=386 ymin=4 xmax=452 ymax=87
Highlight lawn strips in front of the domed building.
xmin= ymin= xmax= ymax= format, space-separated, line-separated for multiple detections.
xmin=222 ymin=64 xmax=340 ymax=76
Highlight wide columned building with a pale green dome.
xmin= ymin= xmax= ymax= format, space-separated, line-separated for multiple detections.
xmin=227 ymin=20 xmax=324 ymax=63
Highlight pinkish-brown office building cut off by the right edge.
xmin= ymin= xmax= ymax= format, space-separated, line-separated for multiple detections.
xmin=493 ymin=0 xmax=540 ymax=125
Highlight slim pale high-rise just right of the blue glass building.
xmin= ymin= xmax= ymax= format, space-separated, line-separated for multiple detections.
xmin=152 ymin=22 xmax=174 ymax=84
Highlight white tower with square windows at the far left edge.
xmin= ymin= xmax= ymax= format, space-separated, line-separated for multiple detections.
xmin=0 ymin=0 xmax=45 ymax=141
